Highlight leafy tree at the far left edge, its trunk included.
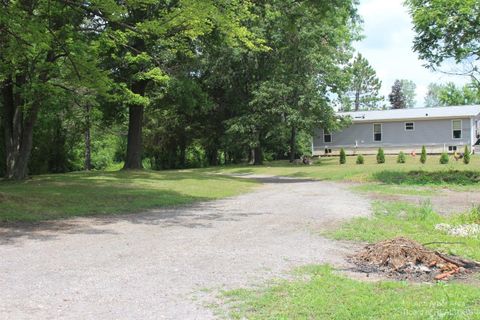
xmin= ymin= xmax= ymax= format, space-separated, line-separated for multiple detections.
xmin=0 ymin=0 xmax=104 ymax=180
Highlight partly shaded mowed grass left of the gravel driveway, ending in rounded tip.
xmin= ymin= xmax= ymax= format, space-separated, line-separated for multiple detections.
xmin=0 ymin=170 xmax=256 ymax=222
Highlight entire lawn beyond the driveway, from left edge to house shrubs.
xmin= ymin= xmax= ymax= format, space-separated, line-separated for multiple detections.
xmin=0 ymin=156 xmax=480 ymax=222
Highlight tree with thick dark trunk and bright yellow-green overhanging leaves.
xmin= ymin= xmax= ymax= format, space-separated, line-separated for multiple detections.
xmin=93 ymin=0 xmax=259 ymax=169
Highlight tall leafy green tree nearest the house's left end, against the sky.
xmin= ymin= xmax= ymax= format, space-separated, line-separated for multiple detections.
xmin=240 ymin=0 xmax=357 ymax=161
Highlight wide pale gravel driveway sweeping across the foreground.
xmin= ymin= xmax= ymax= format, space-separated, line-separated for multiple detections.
xmin=0 ymin=178 xmax=370 ymax=319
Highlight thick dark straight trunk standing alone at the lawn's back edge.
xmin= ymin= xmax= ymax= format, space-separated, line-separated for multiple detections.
xmin=123 ymin=81 xmax=147 ymax=170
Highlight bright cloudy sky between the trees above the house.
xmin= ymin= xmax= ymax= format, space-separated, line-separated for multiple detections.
xmin=355 ymin=0 xmax=469 ymax=107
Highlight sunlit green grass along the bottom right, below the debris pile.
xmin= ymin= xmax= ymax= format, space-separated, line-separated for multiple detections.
xmin=223 ymin=266 xmax=480 ymax=320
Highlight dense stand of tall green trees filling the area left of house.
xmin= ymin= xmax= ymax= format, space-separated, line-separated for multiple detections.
xmin=0 ymin=0 xmax=360 ymax=179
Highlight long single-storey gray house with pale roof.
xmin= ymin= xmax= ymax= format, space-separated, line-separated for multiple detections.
xmin=312 ymin=105 xmax=480 ymax=155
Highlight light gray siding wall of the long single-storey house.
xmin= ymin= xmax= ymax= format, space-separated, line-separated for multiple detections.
xmin=313 ymin=118 xmax=475 ymax=154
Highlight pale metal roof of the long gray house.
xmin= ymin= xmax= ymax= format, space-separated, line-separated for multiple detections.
xmin=338 ymin=105 xmax=480 ymax=122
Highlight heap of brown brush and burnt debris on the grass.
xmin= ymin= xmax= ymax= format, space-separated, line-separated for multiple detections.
xmin=351 ymin=237 xmax=480 ymax=281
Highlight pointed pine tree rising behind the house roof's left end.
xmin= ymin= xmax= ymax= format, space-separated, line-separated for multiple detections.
xmin=342 ymin=53 xmax=383 ymax=111
